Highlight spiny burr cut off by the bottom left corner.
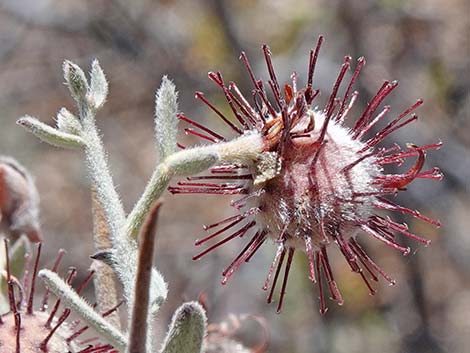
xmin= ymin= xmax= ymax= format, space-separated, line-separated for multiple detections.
xmin=0 ymin=240 xmax=121 ymax=353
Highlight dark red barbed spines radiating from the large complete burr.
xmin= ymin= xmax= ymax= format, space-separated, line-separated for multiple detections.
xmin=169 ymin=36 xmax=442 ymax=314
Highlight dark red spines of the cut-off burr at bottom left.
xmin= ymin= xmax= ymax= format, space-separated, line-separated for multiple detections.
xmin=0 ymin=239 xmax=122 ymax=353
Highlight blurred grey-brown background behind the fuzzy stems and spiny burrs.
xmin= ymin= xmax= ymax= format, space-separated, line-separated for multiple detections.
xmin=0 ymin=0 xmax=470 ymax=353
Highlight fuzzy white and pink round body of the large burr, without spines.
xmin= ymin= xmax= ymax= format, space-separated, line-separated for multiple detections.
xmin=258 ymin=112 xmax=380 ymax=249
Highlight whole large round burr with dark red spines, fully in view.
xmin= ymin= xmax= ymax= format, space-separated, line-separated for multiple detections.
xmin=169 ymin=37 xmax=442 ymax=314
